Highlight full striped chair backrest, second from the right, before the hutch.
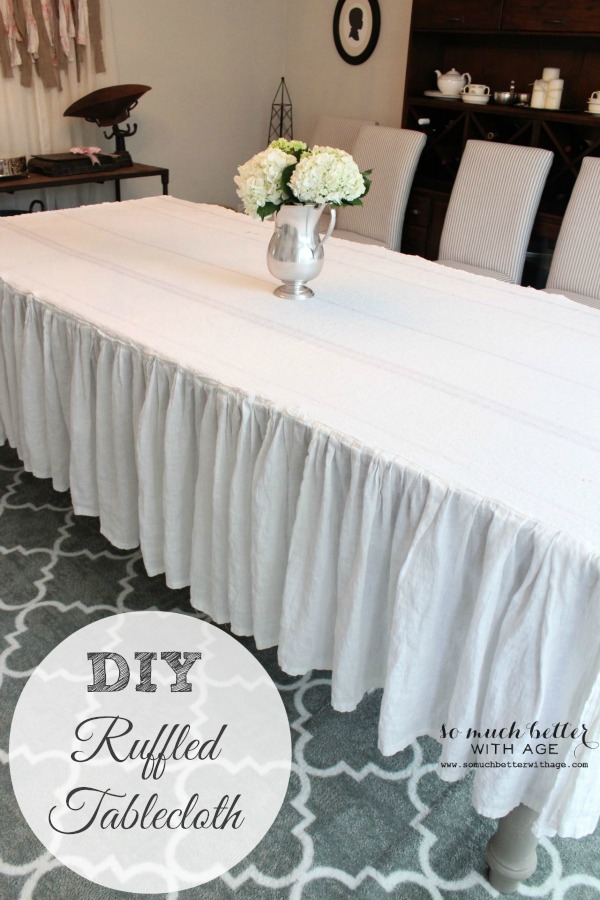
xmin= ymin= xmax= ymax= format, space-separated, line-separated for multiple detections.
xmin=438 ymin=141 xmax=553 ymax=284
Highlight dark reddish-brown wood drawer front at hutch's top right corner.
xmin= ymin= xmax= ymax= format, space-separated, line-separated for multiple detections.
xmin=502 ymin=0 xmax=600 ymax=34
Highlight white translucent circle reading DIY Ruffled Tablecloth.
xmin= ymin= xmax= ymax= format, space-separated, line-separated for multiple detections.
xmin=9 ymin=612 xmax=291 ymax=894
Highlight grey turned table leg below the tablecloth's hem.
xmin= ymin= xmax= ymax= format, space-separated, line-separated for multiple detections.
xmin=486 ymin=804 xmax=538 ymax=894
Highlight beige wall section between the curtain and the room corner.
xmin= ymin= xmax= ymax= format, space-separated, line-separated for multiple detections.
xmin=107 ymin=0 xmax=285 ymax=205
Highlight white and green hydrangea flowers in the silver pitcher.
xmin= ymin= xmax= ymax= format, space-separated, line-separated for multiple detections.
xmin=234 ymin=138 xmax=371 ymax=219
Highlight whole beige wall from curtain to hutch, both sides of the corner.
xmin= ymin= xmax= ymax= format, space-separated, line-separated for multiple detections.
xmin=104 ymin=0 xmax=411 ymax=206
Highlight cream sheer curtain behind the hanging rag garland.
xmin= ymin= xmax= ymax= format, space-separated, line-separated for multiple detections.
xmin=0 ymin=2 xmax=119 ymax=209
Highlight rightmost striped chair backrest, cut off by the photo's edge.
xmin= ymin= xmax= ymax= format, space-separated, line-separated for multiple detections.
xmin=546 ymin=156 xmax=600 ymax=306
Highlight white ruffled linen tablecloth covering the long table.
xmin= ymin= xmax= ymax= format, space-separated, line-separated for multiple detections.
xmin=0 ymin=197 xmax=600 ymax=837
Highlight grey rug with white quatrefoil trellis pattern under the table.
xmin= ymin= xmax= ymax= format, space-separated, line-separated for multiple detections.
xmin=0 ymin=445 xmax=600 ymax=900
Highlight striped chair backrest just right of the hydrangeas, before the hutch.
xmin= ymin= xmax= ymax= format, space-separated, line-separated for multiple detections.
xmin=334 ymin=125 xmax=427 ymax=250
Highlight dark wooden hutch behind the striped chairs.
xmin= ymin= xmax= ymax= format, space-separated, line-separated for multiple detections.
xmin=402 ymin=0 xmax=600 ymax=287
